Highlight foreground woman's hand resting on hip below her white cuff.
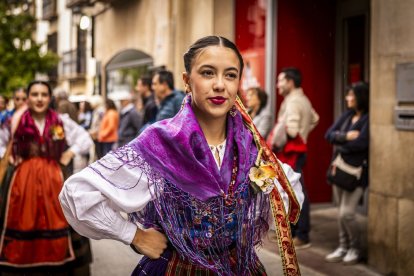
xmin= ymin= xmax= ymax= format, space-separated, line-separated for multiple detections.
xmin=132 ymin=228 xmax=168 ymax=259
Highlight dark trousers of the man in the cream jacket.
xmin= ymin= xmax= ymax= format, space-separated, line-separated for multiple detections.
xmin=291 ymin=153 xmax=310 ymax=242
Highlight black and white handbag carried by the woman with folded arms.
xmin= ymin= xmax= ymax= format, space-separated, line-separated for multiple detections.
xmin=327 ymin=154 xmax=363 ymax=192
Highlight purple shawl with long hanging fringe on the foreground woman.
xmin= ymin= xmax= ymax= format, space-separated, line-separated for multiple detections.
xmin=91 ymin=97 xmax=269 ymax=275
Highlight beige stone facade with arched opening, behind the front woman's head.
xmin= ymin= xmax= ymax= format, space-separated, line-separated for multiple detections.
xmin=94 ymin=0 xmax=234 ymax=94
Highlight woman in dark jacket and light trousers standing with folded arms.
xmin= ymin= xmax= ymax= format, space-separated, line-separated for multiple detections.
xmin=325 ymin=82 xmax=369 ymax=264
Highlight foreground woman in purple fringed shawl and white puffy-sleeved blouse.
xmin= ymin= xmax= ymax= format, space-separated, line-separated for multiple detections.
xmin=60 ymin=36 xmax=303 ymax=275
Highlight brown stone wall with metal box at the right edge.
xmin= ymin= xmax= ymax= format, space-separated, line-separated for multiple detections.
xmin=368 ymin=0 xmax=414 ymax=275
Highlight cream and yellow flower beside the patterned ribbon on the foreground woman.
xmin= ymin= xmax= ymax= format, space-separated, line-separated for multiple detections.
xmin=249 ymin=162 xmax=276 ymax=194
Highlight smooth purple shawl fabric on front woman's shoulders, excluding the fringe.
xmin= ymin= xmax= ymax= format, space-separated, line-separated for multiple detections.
xmin=130 ymin=96 xmax=257 ymax=201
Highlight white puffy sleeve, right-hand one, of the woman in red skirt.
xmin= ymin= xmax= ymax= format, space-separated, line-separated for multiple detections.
xmin=59 ymin=114 xmax=93 ymax=154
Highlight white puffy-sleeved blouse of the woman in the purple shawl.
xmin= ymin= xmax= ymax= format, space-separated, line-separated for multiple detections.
xmin=59 ymin=145 xmax=304 ymax=244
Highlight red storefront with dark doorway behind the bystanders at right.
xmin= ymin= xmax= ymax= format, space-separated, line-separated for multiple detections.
xmin=235 ymin=0 xmax=368 ymax=202
